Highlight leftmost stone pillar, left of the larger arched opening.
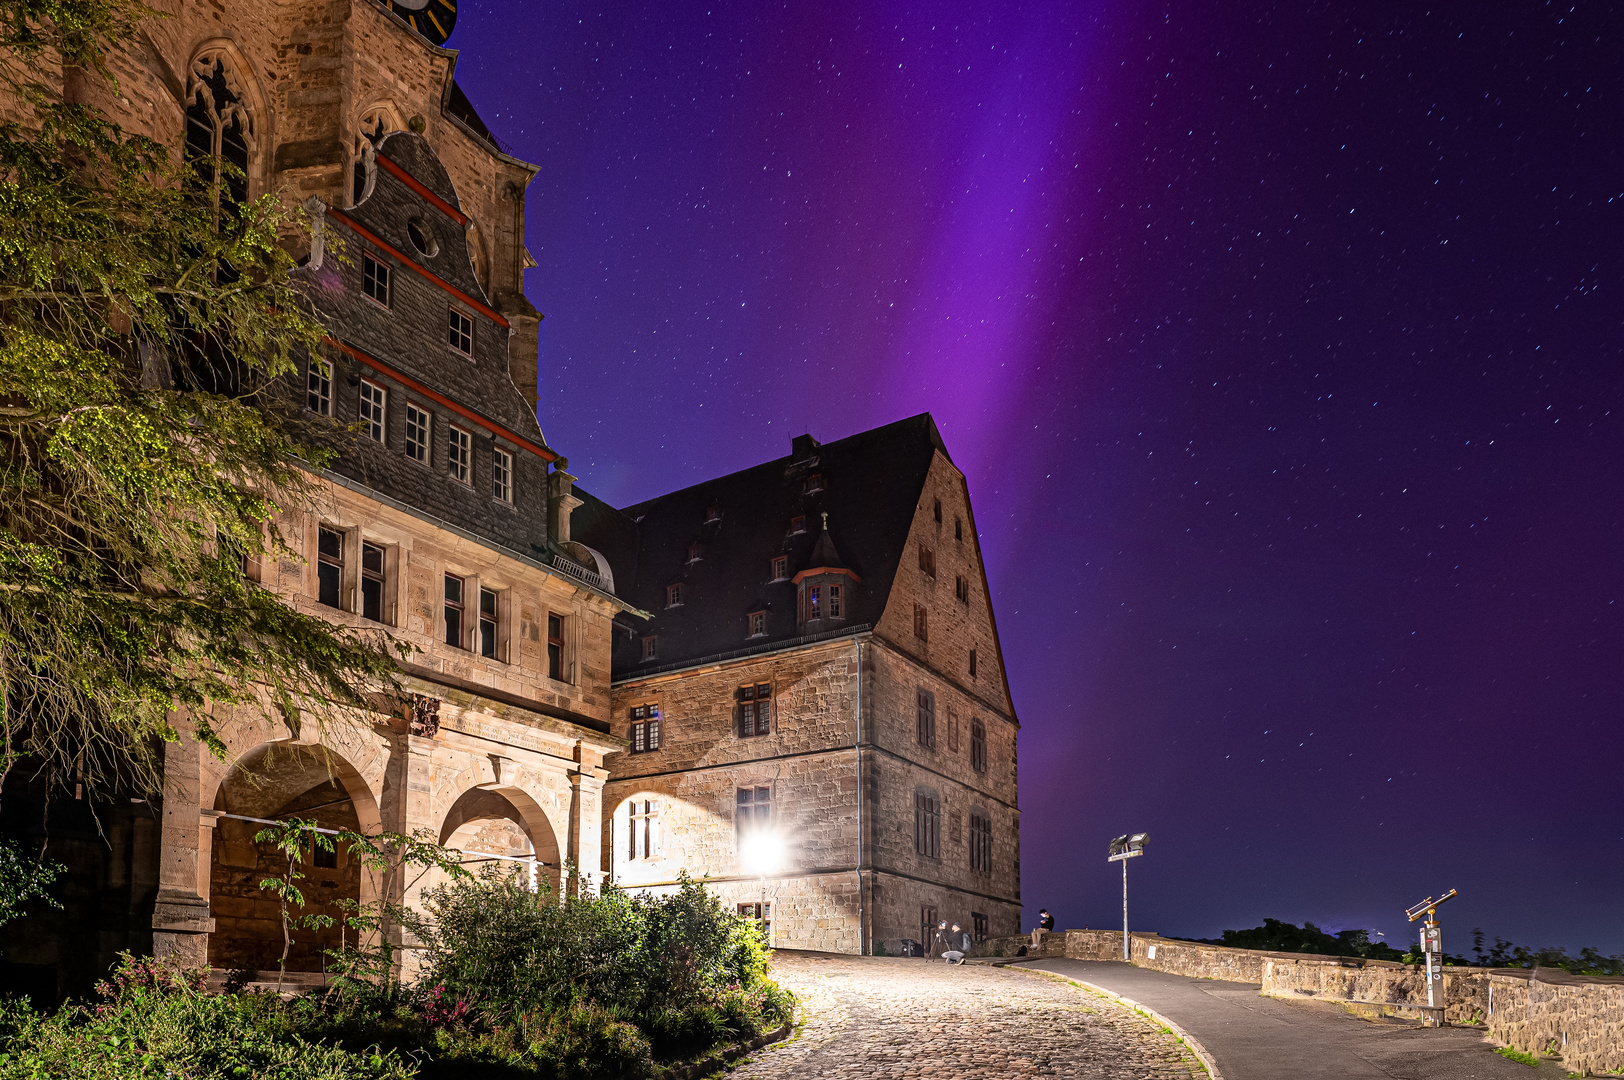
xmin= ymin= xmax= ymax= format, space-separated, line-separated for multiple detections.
xmin=153 ymin=734 xmax=214 ymax=968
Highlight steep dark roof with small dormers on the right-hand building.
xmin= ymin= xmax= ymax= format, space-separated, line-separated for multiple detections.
xmin=570 ymin=413 xmax=947 ymax=679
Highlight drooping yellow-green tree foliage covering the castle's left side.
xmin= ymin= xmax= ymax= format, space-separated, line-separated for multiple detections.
xmin=0 ymin=0 xmax=404 ymax=788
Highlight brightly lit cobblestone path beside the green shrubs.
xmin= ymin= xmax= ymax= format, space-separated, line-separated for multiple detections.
xmin=729 ymin=953 xmax=1207 ymax=1080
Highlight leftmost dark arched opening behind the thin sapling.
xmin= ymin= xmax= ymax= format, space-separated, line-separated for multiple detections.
xmin=208 ymin=739 xmax=382 ymax=971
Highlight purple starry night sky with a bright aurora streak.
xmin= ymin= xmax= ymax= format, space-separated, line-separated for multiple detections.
xmin=448 ymin=0 xmax=1624 ymax=952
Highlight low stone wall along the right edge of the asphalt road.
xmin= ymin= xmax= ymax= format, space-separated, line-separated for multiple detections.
xmin=974 ymin=931 xmax=1624 ymax=1075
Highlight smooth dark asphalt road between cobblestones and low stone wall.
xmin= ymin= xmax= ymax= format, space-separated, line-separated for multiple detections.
xmin=1021 ymin=960 xmax=1566 ymax=1080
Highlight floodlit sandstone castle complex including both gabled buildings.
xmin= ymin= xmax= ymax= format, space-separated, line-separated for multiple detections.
xmin=0 ymin=0 xmax=1020 ymax=996
